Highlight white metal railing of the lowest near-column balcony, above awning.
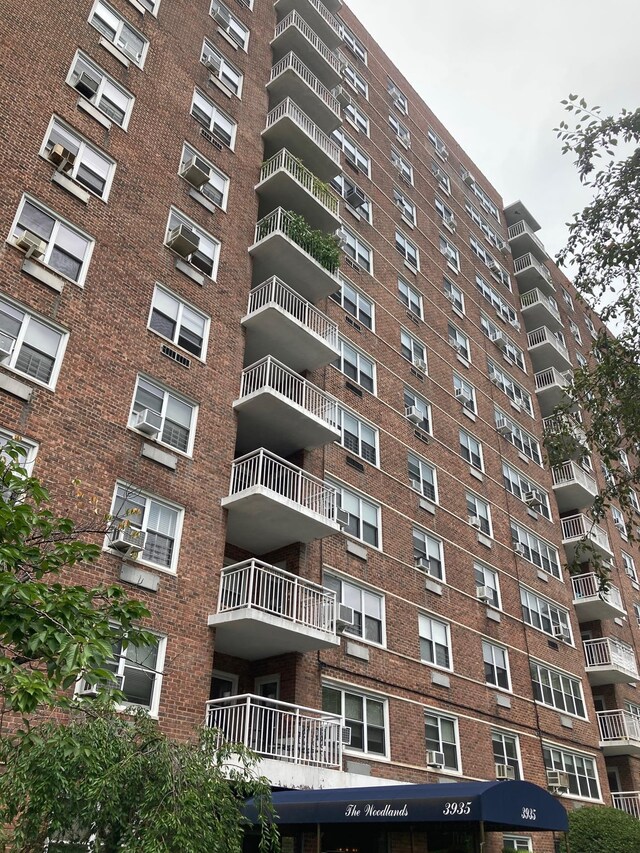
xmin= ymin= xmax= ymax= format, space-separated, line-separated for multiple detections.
xmin=206 ymin=693 xmax=342 ymax=769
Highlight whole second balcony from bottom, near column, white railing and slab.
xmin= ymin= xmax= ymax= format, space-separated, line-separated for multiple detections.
xmin=209 ymin=560 xmax=340 ymax=660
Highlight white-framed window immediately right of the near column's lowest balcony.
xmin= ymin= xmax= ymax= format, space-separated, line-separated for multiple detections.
xmin=322 ymin=685 xmax=389 ymax=755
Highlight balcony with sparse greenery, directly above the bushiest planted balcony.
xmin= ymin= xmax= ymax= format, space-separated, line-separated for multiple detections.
xmin=255 ymin=148 xmax=340 ymax=231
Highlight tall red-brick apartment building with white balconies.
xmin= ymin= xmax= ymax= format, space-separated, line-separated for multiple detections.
xmin=0 ymin=0 xmax=640 ymax=851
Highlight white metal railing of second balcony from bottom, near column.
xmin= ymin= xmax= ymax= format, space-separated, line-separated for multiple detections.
xmin=218 ymin=560 xmax=336 ymax=634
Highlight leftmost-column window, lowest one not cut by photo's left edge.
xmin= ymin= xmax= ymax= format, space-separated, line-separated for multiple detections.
xmin=11 ymin=196 xmax=93 ymax=284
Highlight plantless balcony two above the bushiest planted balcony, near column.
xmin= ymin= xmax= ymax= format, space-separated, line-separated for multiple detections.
xmin=262 ymin=98 xmax=340 ymax=181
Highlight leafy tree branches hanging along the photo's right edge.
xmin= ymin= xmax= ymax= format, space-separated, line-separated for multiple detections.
xmin=545 ymin=100 xmax=640 ymax=583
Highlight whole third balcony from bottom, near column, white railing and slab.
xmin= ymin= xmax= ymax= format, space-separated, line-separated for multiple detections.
xmin=221 ymin=448 xmax=341 ymax=554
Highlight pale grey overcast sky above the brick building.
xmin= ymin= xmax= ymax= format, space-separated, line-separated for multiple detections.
xmin=346 ymin=0 xmax=640 ymax=254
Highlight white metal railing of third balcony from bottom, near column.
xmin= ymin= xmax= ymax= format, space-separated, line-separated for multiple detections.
xmin=229 ymin=448 xmax=336 ymax=521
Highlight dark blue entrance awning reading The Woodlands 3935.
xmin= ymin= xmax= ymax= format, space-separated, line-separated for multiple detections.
xmin=246 ymin=781 xmax=568 ymax=832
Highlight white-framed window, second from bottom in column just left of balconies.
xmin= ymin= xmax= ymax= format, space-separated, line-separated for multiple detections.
xmin=106 ymin=483 xmax=184 ymax=572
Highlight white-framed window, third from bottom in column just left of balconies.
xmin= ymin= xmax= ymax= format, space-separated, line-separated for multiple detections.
xmin=129 ymin=376 xmax=197 ymax=454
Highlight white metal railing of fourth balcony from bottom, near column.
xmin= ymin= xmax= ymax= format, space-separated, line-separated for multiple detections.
xmin=240 ymin=355 xmax=338 ymax=429
